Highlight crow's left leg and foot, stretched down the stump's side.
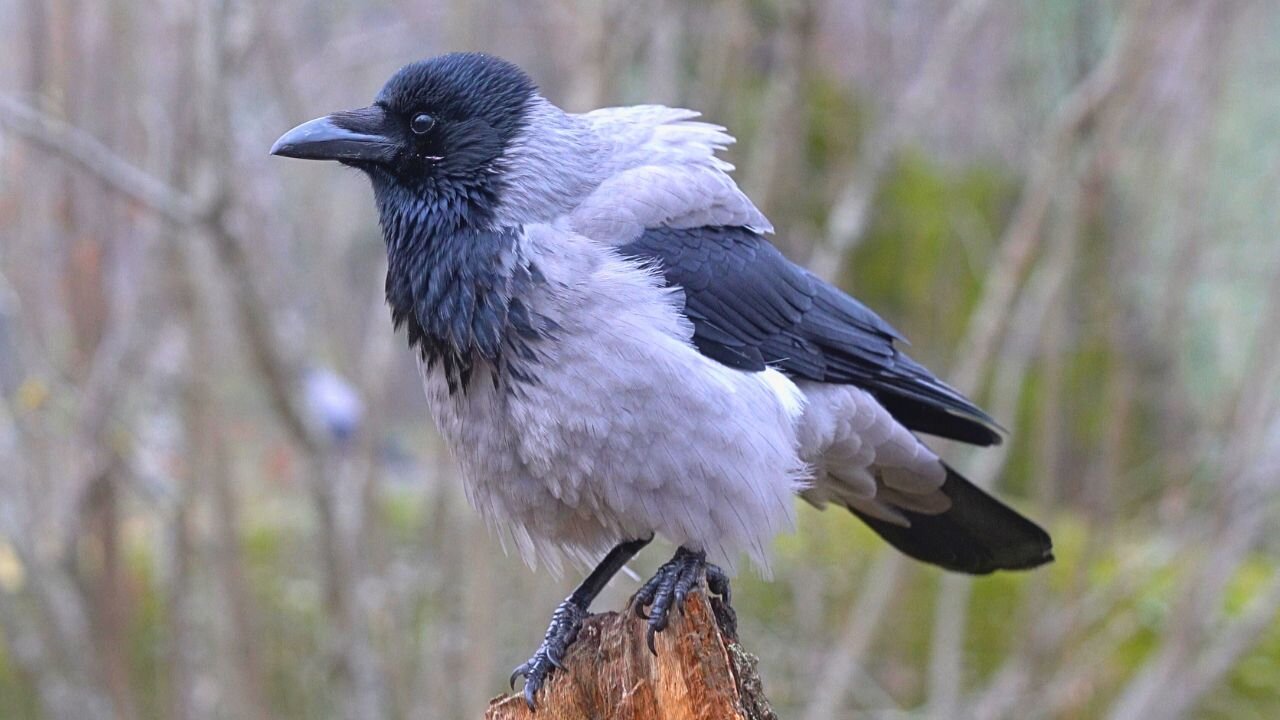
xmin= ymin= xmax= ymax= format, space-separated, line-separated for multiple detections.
xmin=511 ymin=536 xmax=653 ymax=710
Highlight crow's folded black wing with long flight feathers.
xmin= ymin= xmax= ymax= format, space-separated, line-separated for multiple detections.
xmin=620 ymin=227 xmax=1001 ymax=445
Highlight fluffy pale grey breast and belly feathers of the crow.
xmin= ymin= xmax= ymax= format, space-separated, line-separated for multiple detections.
xmin=414 ymin=225 xmax=805 ymax=568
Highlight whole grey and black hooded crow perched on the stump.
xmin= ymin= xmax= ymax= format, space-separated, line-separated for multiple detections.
xmin=271 ymin=53 xmax=1053 ymax=708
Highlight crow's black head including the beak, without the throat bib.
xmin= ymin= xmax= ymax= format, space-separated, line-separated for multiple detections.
xmin=271 ymin=53 xmax=538 ymax=187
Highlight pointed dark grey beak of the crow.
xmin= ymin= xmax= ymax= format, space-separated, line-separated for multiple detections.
xmin=271 ymin=106 xmax=396 ymax=163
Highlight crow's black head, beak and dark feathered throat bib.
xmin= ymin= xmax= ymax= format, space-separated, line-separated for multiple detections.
xmin=271 ymin=53 xmax=538 ymax=392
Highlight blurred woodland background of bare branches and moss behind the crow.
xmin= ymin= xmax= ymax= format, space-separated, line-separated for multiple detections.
xmin=0 ymin=0 xmax=1280 ymax=720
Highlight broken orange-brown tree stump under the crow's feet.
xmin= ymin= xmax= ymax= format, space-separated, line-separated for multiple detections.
xmin=485 ymin=588 xmax=777 ymax=720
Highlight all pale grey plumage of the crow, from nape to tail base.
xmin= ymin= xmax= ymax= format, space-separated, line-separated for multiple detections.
xmin=424 ymin=97 xmax=948 ymax=569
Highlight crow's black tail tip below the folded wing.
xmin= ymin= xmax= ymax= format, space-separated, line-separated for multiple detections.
xmin=850 ymin=468 xmax=1053 ymax=575
